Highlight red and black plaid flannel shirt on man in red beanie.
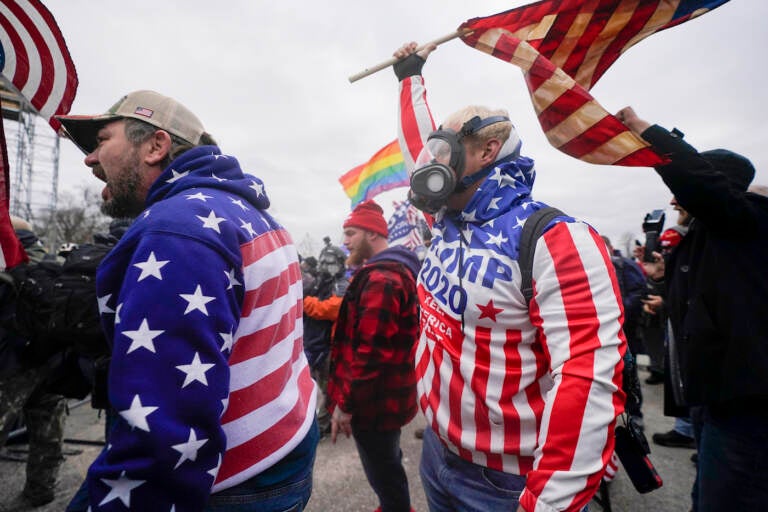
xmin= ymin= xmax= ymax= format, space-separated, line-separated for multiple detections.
xmin=328 ymin=261 xmax=419 ymax=430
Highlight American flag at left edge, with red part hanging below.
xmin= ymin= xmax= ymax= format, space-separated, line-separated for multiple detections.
xmin=0 ymin=0 xmax=77 ymax=268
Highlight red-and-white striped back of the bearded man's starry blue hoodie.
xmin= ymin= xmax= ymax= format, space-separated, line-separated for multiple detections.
xmin=212 ymin=229 xmax=315 ymax=492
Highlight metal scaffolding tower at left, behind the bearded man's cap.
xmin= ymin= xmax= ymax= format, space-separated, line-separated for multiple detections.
xmin=0 ymin=84 xmax=59 ymax=247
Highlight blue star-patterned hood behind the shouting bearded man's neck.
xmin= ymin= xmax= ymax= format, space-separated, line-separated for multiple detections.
xmin=147 ymin=146 xmax=269 ymax=210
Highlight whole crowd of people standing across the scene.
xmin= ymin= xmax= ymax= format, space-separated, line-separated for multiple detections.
xmin=0 ymin=39 xmax=768 ymax=512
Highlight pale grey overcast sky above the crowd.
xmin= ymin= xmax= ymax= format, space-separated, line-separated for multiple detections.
xmin=44 ymin=0 xmax=768 ymax=256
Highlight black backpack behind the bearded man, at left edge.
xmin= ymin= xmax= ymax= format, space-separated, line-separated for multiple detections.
xmin=6 ymin=243 xmax=113 ymax=364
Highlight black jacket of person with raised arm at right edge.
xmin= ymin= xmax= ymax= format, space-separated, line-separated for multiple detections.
xmin=642 ymin=126 xmax=768 ymax=410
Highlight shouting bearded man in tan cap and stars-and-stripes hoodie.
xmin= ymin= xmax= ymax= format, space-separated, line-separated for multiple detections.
xmin=59 ymin=91 xmax=318 ymax=512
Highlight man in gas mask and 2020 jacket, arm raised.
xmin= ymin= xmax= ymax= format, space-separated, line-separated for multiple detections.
xmin=394 ymin=43 xmax=626 ymax=512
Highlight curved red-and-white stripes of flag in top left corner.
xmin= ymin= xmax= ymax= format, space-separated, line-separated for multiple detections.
xmin=0 ymin=0 xmax=78 ymax=131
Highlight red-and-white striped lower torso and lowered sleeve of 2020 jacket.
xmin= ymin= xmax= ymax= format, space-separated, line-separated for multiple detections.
xmin=416 ymin=219 xmax=626 ymax=510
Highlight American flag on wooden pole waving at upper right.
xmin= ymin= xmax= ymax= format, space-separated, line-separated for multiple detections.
xmin=460 ymin=0 xmax=728 ymax=166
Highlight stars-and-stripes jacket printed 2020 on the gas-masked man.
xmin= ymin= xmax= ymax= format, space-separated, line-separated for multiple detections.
xmin=400 ymin=76 xmax=626 ymax=511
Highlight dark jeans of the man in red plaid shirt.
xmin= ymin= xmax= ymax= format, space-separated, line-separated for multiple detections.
xmin=352 ymin=426 xmax=411 ymax=512
